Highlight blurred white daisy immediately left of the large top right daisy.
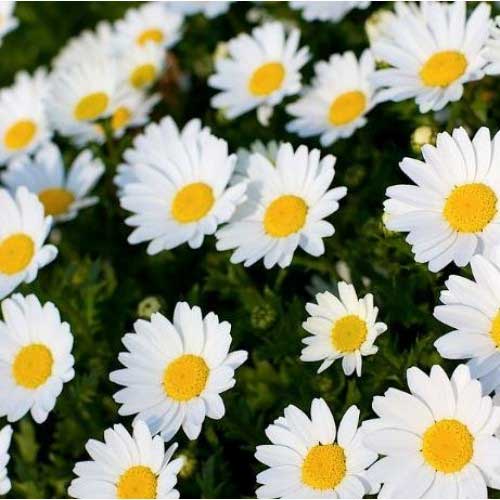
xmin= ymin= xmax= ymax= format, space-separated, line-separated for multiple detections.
xmin=286 ymin=50 xmax=375 ymax=146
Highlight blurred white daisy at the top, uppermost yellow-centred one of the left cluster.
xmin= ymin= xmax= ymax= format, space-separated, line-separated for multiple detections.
xmin=115 ymin=2 xmax=183 ymax=48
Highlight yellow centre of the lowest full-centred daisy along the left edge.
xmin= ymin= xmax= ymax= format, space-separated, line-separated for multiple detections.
xmin=12 ymin=344 xmax=54 ymax=389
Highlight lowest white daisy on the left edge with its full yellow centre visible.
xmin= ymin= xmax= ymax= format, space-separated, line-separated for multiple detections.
xmin=0 ymin=293 xmax=75 ymax=424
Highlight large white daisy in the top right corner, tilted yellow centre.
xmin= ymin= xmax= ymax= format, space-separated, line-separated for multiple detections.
xmin=372 ymin=1 xmax=490 ymax=113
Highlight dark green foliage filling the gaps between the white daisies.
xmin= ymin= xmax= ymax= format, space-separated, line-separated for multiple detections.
xmin=0 ymin=2 xmax=500 ymax=498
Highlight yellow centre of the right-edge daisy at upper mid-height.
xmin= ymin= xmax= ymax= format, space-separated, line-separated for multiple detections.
xmin=443 ymin=183 xmax=497 ymax=233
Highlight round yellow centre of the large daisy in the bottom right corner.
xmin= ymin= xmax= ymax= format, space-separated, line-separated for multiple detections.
xmin=422 ymin=419 xmax=474 ymax=474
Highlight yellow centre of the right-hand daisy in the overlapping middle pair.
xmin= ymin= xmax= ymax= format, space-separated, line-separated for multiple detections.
xmin=264 ymin=194 xmax=307 ymax=238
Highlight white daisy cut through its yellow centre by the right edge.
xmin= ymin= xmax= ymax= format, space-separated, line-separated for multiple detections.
xmin=434 ymin=255 xmax=500 ymax=394
